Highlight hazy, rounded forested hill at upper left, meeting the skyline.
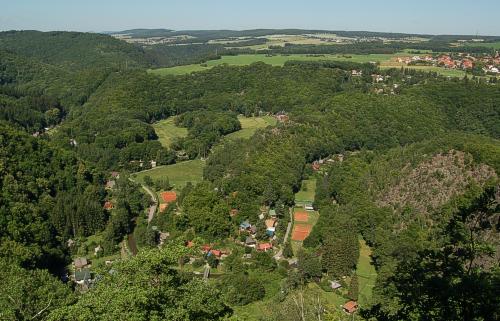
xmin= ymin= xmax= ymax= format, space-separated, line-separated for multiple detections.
xmin=0 ymin=31 xmax=148 ymax=107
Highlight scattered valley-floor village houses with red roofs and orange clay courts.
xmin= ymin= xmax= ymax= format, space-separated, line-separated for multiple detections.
xmin=68 ymin=148 xmax=368 ymax=314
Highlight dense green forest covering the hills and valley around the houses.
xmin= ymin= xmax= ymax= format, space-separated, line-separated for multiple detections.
xmin=0 ymin=30 xmax=500 ymax=320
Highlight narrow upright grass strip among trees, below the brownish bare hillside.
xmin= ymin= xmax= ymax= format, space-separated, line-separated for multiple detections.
xmin=356 ymin=239 xmax=377 ymax=305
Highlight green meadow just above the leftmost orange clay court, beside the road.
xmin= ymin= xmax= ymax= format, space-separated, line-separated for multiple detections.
xmin=134 ymin=159 xmax=205 ymax=191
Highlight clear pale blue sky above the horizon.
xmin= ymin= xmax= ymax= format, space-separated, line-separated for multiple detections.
xmin=0 ymin=0 xmax=500 ymax=36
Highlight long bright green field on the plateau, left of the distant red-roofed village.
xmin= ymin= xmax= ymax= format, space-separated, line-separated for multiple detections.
xmin=149 ymin=53 xmax=408 ymax=75
